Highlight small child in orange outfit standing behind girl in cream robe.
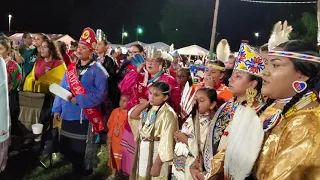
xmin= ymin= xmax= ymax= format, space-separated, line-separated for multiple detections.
xmin=107 ymin=95 xmax=129 ymax=179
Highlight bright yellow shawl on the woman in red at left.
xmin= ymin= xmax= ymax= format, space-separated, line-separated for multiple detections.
xmin=23 ymin=63 xmax=67 ymax=93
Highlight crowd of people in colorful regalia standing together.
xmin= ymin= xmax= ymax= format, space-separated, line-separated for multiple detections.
xmin=0 ymin=19 xmax=320 ymax=180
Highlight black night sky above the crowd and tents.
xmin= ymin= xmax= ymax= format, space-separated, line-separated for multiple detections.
xmin=0 ymin=0 xmax=315 ymax=50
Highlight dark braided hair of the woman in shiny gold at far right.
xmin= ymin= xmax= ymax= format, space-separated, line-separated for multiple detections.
xmin=258 ymin=40 xmax=320 ymax=115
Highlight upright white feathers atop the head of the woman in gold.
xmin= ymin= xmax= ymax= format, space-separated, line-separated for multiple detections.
xmin=268 ymin=21 xmax=293 ymax=51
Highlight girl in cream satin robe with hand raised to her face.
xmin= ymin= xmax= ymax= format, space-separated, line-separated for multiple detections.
xmin=129 ymin=81 xmax=178 ymax=180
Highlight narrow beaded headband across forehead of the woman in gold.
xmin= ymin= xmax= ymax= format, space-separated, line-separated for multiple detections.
xmin=268 ymin=51 xmax=320 ymax=63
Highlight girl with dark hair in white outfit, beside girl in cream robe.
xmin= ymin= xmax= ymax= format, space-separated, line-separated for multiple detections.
xmin=172 ymin=88 xmax=218 ymax=180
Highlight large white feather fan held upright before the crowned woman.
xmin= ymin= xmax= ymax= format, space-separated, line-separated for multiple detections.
xmin=224 ymin=106 xmax=264 ymax=180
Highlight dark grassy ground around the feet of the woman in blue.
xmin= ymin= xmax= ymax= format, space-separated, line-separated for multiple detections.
xmin=23 ymin=146 xmax=111 ymax=180
